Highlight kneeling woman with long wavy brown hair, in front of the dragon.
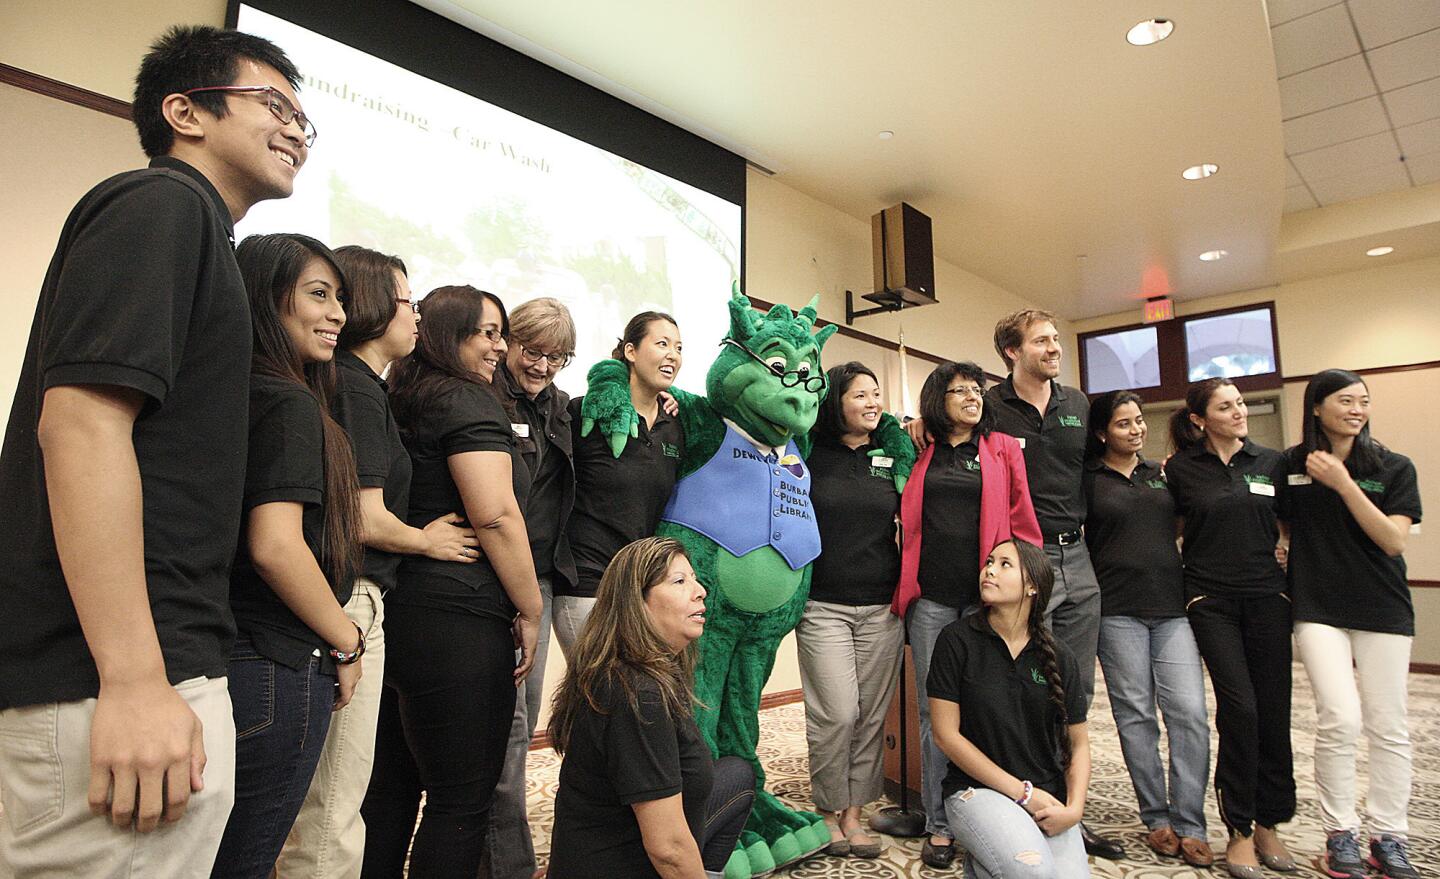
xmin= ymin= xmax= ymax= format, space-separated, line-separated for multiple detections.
xmin=549 ymin=537 xmax=755 ymax=879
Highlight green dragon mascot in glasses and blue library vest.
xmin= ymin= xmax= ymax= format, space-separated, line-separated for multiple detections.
xmin=580 ymin=287 xmax=914 ymax=879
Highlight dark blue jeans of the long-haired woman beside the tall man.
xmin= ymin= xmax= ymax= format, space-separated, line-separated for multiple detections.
xmin=210 ymin=634 xmax=336 ymax=879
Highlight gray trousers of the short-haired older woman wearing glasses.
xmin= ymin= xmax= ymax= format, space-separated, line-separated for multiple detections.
xmin=480 ymin=576 xmax=550 ymax=879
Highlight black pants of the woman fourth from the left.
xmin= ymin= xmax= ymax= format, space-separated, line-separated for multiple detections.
xmin=360 ymin=602 xmax=516 ymax=879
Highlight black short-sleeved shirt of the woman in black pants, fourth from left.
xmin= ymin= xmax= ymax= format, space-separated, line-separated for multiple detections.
xmin=386 ymin=379 xmax=530 ymax=623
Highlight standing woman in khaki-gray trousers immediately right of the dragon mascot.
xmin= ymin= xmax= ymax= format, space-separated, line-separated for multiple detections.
xmin=795 ymin=362 xmax=904 ymax=857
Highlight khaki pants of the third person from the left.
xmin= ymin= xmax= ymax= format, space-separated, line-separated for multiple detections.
xmin=274 ymin=576 xmax=384 ymax=879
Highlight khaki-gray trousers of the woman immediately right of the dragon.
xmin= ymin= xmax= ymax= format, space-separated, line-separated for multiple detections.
xmin=795 ymin=601 xmax=904 ymax=811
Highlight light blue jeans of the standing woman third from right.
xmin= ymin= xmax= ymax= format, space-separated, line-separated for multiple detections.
xmin=1099 ymin=617 xmax=1210 ymax=839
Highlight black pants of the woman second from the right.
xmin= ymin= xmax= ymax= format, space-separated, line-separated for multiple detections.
xmin=1189 ymin=594 xmax=1295 ymax=836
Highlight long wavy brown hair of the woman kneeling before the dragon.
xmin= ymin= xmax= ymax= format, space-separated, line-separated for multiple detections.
xmin=550 ymin=537 xmax=696 ymax=754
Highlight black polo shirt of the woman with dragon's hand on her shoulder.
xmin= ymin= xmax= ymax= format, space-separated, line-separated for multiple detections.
xmin=554 ymin=396 xmax=685 ymax=598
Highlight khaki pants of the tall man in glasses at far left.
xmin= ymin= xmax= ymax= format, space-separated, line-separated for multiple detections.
xmin=0 ymin=677 xmax=235 ymax=879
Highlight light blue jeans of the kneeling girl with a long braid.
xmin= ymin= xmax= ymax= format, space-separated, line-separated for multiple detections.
xmin=945 ymin=788 xmax=1090 ymax=879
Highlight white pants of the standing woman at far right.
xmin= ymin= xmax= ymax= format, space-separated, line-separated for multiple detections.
xmin=1295 ymin=623 xmax=1411 ymax=836
